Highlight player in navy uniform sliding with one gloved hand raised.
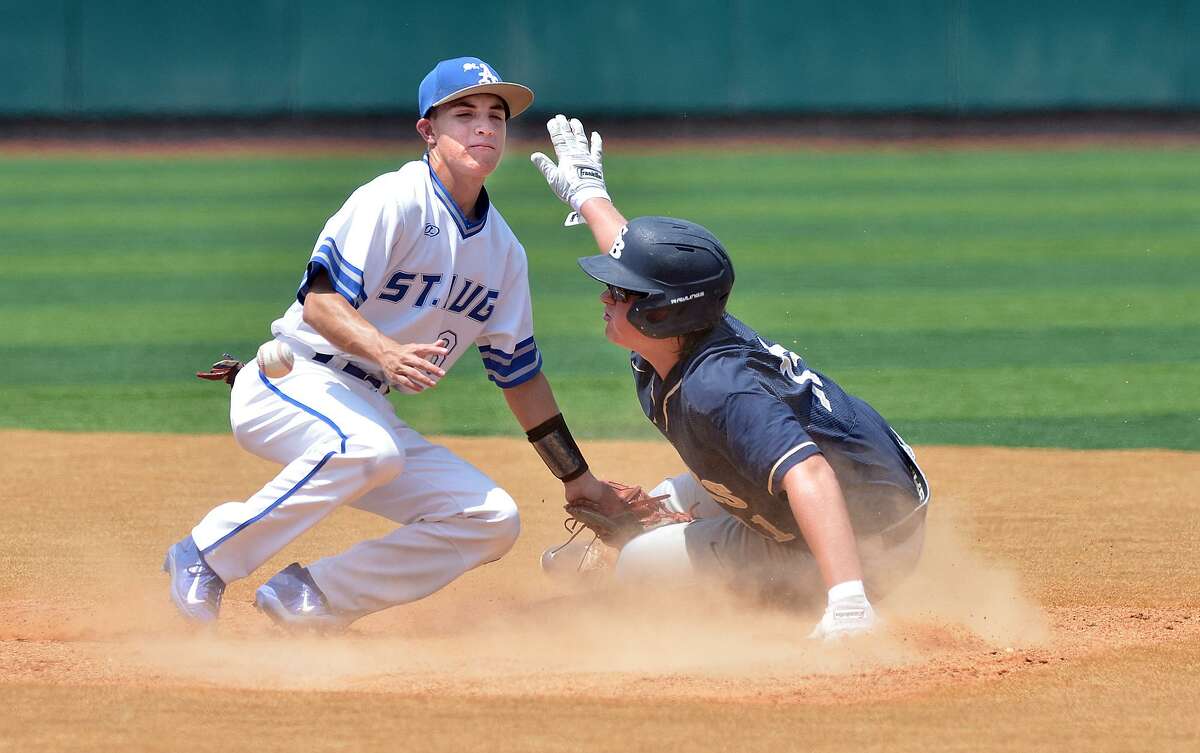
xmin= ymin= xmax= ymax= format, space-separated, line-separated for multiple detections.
xmin=533 ymin=116 xmax=929 ymax=638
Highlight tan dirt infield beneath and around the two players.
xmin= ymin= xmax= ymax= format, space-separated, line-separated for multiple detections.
xmin=0 ymin=432 xmax=1200 ymax=752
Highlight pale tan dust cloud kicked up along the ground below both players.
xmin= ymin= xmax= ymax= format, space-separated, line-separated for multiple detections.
xmin=51 ymin=501 xmax=1049 ymax=697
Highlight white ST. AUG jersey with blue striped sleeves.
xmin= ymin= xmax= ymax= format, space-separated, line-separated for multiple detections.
xmin=271 ymin=153 xmax=541 ymax=387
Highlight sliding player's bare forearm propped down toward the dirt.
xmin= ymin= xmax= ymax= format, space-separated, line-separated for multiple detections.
xmin=784 ymin=454 xmax=863 ymax=589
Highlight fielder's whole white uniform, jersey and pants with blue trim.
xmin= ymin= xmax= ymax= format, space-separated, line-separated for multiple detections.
xmin=192 ymin=154 xmax=541 ymax=616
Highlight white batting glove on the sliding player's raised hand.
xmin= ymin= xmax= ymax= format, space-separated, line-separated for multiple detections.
xmin=529 ymin=115 xmax=608 ymax=225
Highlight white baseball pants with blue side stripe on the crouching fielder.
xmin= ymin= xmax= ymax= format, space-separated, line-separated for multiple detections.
xmin=192 ymin=356 xmax=521 ymax=615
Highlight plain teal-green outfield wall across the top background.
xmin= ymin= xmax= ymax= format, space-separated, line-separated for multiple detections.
xmin=0 ymin=0 xmax=1200 ymax=118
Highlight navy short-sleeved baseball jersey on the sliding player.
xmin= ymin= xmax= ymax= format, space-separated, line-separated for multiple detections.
xmin=632 ymin=314 xmax=929 ymax=546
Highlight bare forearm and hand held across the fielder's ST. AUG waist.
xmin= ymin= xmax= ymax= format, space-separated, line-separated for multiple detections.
xmin=304 ymin=272 xmax=449 ymax=391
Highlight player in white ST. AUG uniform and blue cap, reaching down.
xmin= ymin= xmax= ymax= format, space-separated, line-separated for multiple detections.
xmin=163 ymin=58 xmax=604 ymax=628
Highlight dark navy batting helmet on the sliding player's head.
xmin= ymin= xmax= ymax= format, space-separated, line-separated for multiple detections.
xmin=580 ymin=217 xmax=733 ymax=338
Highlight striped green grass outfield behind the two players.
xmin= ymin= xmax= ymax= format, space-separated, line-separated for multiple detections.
xmin=0 ymin=144 xmax=1200 ymax=450
